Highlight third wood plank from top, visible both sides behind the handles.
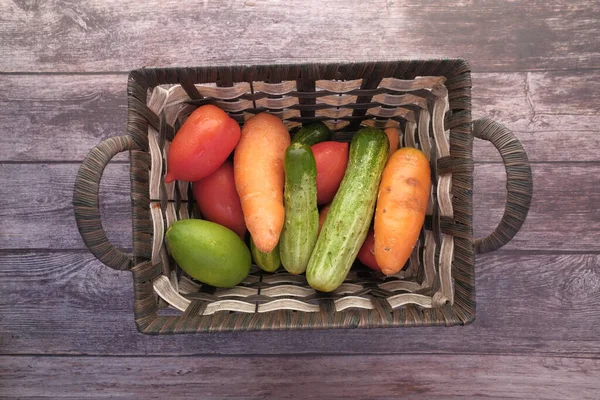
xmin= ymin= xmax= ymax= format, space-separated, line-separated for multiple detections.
xmin=0 ymin=163 xmax=600 ymax=251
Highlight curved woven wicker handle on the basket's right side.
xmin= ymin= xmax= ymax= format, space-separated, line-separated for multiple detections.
xmin=473 ymin=118 xmax=533 ymax=254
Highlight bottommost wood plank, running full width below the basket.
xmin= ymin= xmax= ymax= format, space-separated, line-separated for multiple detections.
xmin=0 ymin=355 xmax=600 ymax=400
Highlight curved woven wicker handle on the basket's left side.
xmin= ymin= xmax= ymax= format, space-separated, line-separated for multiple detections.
xmin=73 ymin=135 xmax=134 ymax=270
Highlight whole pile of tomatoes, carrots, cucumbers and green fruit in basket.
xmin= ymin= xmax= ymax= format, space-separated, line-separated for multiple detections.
xmin=165 ymin=105 xmax=431 ymax=292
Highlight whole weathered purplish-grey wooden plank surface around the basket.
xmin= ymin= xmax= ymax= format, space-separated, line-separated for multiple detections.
xmin=0 ymin=0 xmax=600 ymax=399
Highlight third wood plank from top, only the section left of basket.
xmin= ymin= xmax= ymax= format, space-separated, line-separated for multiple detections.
xmin=0 ymin=164 xmax=132 ymax=250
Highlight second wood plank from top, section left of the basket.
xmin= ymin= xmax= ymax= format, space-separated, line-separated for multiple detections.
xmin=0 ymin=75 xmax=127 ymax=162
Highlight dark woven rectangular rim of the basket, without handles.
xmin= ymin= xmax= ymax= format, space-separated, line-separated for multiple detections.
xmin=127 ymin=58 xmax=475 ymax=334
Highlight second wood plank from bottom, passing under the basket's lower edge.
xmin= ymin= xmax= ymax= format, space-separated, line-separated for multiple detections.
xmin=0 ymin=251 xmax=600 ymax=354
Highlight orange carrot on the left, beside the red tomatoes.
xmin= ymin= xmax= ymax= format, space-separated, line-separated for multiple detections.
xmin=233 ymin=113 xmax=290 ymax=253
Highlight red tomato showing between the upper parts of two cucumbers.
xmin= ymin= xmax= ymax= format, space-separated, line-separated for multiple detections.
xmin=311 ymin=142 xmax=348 ymax=204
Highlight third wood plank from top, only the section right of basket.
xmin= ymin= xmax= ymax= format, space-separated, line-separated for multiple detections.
xmin=473 ymin=163 xmax=600 ymax=251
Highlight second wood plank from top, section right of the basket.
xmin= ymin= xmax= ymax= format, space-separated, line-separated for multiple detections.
xmin=472 ymin=70 xmax=600 ymax=162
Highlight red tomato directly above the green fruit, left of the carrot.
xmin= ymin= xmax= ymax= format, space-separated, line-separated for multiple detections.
xmin=192 ymin=160 xmax=246 ymax=240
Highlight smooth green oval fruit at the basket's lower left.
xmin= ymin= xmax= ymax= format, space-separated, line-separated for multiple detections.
xmin=166 ymin=219 xmax=252 ymax=287
